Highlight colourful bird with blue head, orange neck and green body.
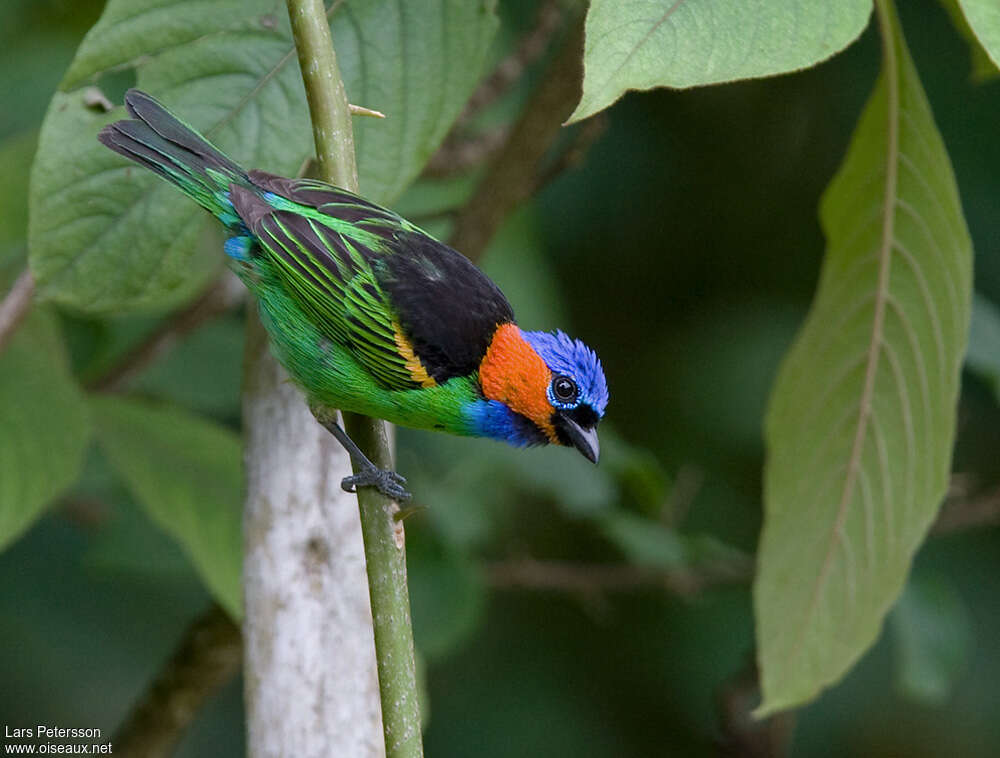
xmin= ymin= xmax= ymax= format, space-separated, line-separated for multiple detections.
xmin=98 ymin=89 xmax=608 ymax=499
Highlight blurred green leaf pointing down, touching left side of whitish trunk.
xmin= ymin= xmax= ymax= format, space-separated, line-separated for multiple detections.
xmin=92 ymin=396 xmax=243 ymax=617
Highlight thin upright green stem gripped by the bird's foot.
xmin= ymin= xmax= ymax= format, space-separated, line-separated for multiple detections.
xmin=288 ymin=0 xmax=423 ymax=758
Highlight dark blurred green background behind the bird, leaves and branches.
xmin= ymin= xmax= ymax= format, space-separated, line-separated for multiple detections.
xmin=0 ymin=0 xmax=1000 ymax=758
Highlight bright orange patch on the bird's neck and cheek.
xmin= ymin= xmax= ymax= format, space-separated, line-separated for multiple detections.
xmin=479 ymin=324 xmax=556 ymax=442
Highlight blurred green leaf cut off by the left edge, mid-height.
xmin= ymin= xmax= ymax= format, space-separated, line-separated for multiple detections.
xmin=0 ymin=307 xmax=90 ymax=548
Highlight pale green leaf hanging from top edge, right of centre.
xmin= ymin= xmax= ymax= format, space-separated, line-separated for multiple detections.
xmin=570 ymin=0 xmax=872 ymax=121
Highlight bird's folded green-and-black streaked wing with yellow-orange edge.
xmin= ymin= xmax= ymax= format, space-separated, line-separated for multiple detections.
xmin=231 ymin=185 xmax=421 ymax=390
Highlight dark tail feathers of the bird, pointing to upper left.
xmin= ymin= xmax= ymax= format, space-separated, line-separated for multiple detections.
xmin=97 ymin=89 xmax=250 ymax=225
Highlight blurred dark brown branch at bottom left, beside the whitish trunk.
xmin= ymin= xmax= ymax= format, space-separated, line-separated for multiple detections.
xmin=112 ymin=606 xmax=243 ymax=758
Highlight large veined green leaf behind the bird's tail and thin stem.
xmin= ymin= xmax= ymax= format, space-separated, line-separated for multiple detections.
xmin=30 ymin=0 xmax=496 ymax=312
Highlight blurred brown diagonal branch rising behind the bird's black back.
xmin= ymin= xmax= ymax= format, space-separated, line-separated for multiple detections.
xmin=449 ymin=18 xmax=583 ymax=260
